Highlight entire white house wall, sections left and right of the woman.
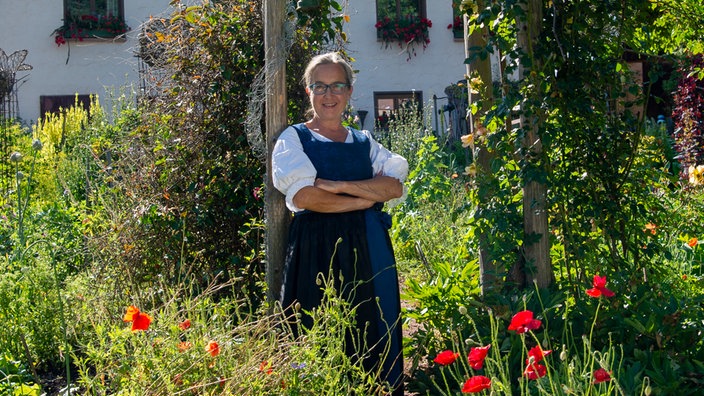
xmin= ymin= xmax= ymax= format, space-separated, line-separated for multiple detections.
xmin=0 ymin=0 xmax=472 ymax=134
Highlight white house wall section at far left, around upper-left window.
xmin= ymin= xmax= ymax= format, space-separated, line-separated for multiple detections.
xmin=0 ymin=0 xmax=169 ymax=124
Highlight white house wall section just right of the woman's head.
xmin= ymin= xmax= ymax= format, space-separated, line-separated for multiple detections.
xmin=345 ymin=0 xmax=465 ymax=133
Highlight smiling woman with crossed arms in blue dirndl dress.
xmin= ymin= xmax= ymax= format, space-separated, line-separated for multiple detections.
xmin=272 ymin=53 xmax=408 ymax=395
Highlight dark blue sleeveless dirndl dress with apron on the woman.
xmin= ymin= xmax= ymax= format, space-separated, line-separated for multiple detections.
xmin=281 ymin=124 xmax=403 ymax=395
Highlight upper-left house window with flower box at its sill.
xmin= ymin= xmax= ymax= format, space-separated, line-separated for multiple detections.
xmin=61 ymin=0 xmax=129 ymax=39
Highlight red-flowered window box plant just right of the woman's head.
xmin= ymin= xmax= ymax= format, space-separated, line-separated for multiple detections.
xmin=374 ymin=15 xmax=433 ymax=59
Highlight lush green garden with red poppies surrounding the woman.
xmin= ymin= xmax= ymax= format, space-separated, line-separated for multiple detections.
xmin=0 ymin=0 xmax=704 ymax=396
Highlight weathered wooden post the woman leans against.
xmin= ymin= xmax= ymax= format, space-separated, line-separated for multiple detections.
xmin=264 ymin=0 xmax=290 ymax=302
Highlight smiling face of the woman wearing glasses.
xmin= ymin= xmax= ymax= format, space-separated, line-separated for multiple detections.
xmin=306 ymin=63 xmax=352 ymax=122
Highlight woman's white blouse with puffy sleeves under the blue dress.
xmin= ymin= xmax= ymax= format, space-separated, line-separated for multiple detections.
xmin=271 ymin=126 xmax=408 ymax=212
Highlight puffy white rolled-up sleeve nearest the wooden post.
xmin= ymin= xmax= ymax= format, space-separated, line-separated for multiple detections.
xmin=271 ymin=127 xmax=317 ymax=212
